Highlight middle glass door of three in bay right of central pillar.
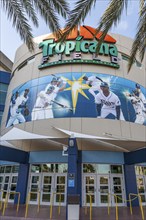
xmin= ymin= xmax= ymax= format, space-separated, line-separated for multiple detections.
xmin=97 ymin=174 xmax=110 ymax=206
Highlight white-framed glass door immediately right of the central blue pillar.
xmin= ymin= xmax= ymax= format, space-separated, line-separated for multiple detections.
xmin=83 ymin=174 xmax=96 ymax=206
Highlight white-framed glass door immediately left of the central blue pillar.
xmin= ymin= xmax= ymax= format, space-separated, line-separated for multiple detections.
xmin=54 ymin=174 xmax=67 ymax=205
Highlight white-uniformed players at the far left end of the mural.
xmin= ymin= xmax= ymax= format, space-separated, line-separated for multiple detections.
xmin=6 ymin=89 xmax=29 ymax=127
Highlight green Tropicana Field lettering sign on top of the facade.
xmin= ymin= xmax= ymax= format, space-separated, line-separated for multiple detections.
xmin=39 ymin=26 xmax=119 ymax=69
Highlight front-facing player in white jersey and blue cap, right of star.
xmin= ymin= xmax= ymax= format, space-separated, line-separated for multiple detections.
xmin=95 ymin=82 xmax=121 ymax=120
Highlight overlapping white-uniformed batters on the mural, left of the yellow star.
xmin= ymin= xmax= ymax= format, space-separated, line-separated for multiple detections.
xmin=31 ymin=77 xmax=66 ymax=121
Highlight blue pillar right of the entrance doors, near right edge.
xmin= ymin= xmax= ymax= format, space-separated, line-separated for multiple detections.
xmin=124 ymin=165 xmax=139 ymax=206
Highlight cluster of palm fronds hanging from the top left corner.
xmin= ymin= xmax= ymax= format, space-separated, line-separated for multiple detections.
xmin=0 ymin=0 xmax=69 ymax=51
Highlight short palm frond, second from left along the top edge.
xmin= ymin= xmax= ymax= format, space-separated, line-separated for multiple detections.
xmin=19 ymin=0 xmax=38 ymax=27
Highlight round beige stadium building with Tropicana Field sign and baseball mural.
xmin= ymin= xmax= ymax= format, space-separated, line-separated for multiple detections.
xmin=0 ymin=26 xmax=146 ymax=213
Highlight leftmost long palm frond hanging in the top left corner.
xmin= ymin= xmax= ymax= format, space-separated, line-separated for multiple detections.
xmin=1 ymin=0 xmax=34 ymax=51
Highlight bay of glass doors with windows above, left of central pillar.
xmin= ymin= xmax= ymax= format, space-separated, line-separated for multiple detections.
xmin=28 ymin=164 xmax=67 ymax=205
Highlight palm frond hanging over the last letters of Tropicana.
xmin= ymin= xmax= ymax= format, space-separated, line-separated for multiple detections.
xmin=95 ymin=0 xmax=128 ymax=54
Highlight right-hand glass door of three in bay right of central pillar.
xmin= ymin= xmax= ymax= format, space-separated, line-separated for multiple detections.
xmin=111 ymin=174 xmax=125 ymax=206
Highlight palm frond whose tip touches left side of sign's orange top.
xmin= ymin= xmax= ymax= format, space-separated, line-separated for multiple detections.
xmin=61 ymin=0 xmax=96 ymax=41
